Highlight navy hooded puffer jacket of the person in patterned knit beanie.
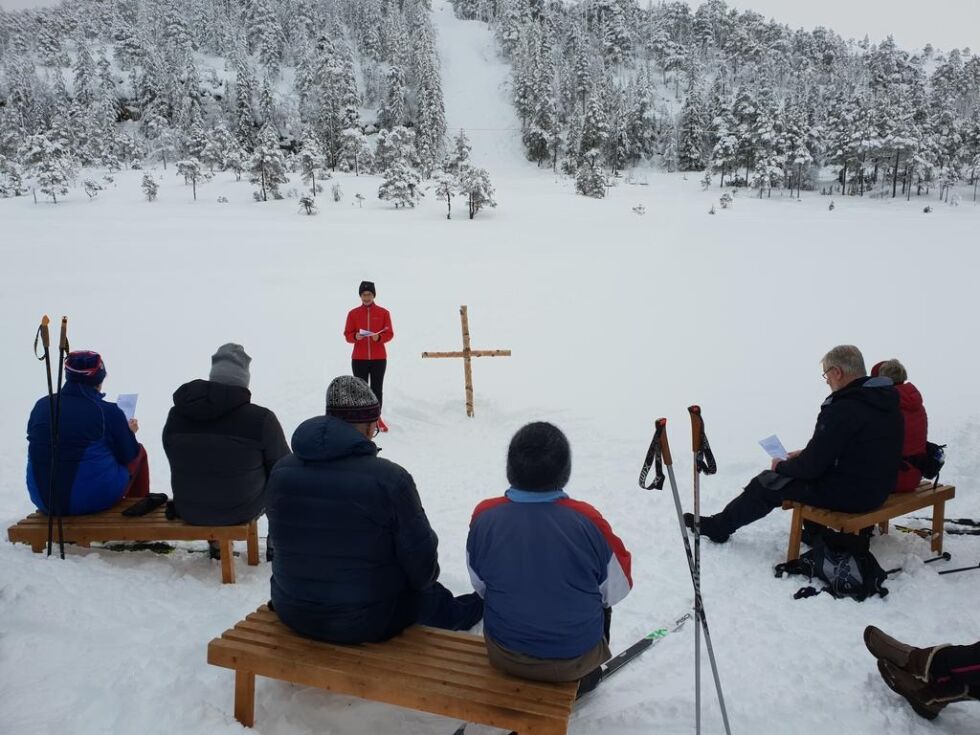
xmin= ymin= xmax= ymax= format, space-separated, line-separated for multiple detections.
xmin=266 ymin=416 xmax=439 ymax=643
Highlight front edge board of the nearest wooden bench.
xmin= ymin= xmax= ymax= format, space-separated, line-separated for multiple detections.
xmin=208 ymin=638 xmax=568 ymax=727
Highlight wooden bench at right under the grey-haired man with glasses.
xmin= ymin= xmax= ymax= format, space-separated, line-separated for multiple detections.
xmin=783 ymin=482 xmax=956 ymax=561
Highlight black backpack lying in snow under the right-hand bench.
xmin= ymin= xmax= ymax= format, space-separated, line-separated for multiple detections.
xmin=775 ymin=529 xmax=888 ymax=602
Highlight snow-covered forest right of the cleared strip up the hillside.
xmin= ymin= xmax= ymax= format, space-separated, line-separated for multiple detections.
xmin=452 ymin=0 xmax=980 ymax=198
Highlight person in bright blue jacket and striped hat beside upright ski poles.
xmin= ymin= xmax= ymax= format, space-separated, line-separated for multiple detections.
xmin=27 ymin=350 xmax=150 ymax=516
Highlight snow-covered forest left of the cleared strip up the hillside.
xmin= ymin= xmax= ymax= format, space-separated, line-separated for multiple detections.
xmin=0 ymin=0 xmax=493 ymax=215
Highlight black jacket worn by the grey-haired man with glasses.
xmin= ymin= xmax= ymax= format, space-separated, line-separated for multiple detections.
xmin=776 ymin=377 xmax=903 ymax=513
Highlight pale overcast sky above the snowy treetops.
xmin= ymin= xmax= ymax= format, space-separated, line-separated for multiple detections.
xmin=0 ymin=0 xmax=980 ymax=53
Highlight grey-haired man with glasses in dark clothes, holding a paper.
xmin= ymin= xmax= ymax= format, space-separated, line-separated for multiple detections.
xmin=685 ymin=345 xmax=903 ymax=543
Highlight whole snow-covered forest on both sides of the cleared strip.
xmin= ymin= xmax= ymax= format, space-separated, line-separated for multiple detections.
xmin=0 ymin=0 xmax=980 ymax=203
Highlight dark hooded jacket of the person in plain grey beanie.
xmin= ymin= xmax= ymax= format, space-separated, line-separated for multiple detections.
xmin=163 ymin=380 xmax=289 ymax=526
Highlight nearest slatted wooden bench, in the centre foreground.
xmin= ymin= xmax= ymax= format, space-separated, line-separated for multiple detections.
xmin=208 ymin=605 xmax=578 ymax=735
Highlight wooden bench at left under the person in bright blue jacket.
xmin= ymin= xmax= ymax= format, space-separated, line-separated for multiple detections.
xmin=7 ymin=498 xmax=259 ymax=584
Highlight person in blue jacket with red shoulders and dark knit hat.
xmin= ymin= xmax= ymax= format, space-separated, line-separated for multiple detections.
xmin=466 ymin=422 xmax=633 ymax=695
